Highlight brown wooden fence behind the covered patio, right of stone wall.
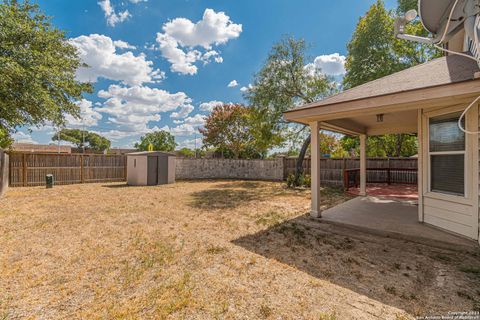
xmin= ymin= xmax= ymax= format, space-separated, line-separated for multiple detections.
xmin=284 ymin=158 xmax=417 ymax=189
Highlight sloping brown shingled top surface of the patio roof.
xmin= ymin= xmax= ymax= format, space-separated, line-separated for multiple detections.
xmin=286 ymin=55 xmax=480 ymax=113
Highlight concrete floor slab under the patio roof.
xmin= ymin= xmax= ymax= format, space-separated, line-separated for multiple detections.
xmin=322 ymin=196 xmax=479 ymax=250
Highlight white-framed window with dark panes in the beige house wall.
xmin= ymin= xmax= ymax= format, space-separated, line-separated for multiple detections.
xmin=429 ymin=113 xmax=465 ymax=196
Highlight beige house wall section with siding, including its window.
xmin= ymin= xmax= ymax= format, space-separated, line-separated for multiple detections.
xmin=422 ymin=106 xmax=478 ymax=239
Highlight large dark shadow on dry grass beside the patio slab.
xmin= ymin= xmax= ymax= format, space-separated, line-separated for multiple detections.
xmin=232 ymin=215 xmax=480 ymax=315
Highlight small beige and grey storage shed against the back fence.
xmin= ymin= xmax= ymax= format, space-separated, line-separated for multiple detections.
xmin=127 ymin=151 xmax=175 ymax=186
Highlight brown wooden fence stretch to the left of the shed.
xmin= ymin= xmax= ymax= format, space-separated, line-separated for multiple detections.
xmin=9 ymin=152 xmax=127 ymax=187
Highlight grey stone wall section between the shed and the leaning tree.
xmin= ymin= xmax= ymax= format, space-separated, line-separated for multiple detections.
xmin=175 ymin=158 xmax=284 ymax=181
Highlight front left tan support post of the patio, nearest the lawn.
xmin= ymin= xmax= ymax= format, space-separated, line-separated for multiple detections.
xmin=310 ymin=121 xmax=322 ymax=218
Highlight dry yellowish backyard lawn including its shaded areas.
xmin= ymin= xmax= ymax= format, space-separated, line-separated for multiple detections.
xmin=0 ymin=181 xmax=480 ymax=319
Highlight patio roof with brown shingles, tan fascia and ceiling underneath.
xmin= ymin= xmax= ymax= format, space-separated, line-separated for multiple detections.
xmin=284 ymin=56 xmax=480 ymax=135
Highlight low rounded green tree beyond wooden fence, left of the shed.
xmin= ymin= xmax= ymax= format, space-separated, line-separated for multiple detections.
xmin=52 ymin=129 xmax=111 ymax=151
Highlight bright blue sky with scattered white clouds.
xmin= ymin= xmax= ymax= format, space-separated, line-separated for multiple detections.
xmin=14 ymin=0 xmax=396 ymax=147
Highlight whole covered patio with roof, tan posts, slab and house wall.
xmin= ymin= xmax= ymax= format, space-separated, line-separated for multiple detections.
xmin=284 ymin=56 xmax=480 ymax=243
